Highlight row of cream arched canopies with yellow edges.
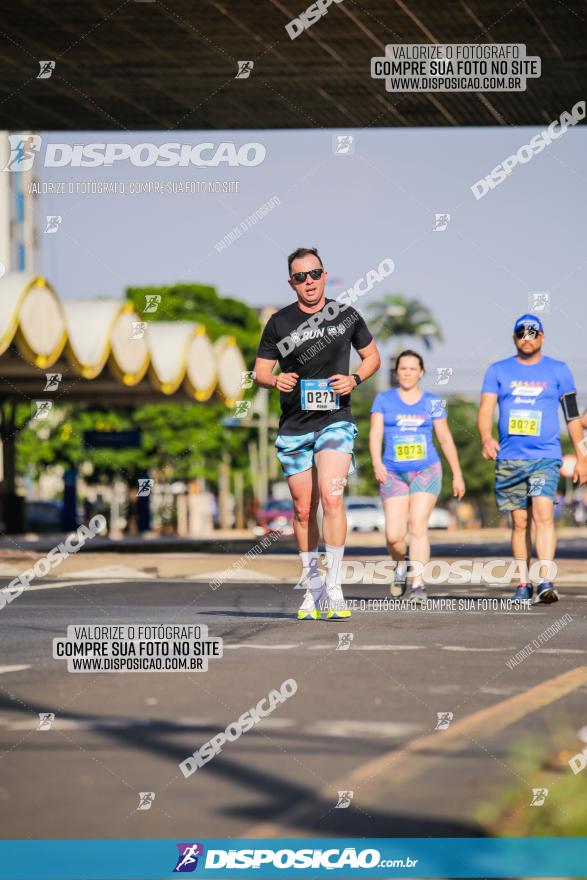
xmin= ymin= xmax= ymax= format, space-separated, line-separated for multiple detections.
xmin=0 ymin=272 xmax=247 ymax=406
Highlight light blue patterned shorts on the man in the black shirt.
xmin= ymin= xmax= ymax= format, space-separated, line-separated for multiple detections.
xmin=275 ymin=422 xmax=357 ymax=477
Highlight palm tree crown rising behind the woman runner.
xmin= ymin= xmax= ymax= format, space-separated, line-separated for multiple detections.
xmin=368 ymin=293 xmax=443 ymax=381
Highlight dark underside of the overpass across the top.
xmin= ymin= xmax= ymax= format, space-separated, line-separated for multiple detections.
xmin=0 ymin=0 xmax=587 ymax=131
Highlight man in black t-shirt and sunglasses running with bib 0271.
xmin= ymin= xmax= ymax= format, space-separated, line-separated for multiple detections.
xmin=255 ymin=248 xmax=381 ymax=620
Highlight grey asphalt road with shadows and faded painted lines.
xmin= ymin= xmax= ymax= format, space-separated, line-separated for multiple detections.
xmin=0 ymin=580 xmax=587 ymax=839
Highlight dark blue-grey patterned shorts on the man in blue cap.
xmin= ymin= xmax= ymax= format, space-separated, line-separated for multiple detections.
xmin=495 ymin=458 xmax=562 ymax=513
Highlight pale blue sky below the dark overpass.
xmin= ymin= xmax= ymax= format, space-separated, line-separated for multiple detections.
xmin=39 ymin=127 xmax=587 ymax=400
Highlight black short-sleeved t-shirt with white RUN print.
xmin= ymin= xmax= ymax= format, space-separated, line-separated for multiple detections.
xmin=257 ymin=299 xmax=373 ymax=434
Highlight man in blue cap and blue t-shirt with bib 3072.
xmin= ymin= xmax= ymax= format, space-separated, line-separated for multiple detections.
xmin=478 ymin=314 xmax=587 ymax=604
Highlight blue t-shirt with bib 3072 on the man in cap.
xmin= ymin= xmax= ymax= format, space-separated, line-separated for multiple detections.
xmin=481 ymin=355 xmax=576 ymax=460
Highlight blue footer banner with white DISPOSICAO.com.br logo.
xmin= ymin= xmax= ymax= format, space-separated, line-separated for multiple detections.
xmin=0 ymin=837 xmax=587 ymax=880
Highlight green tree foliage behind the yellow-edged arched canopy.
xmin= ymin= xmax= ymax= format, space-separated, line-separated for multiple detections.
xmin=17 ymin=284 xmax=261 ymax=485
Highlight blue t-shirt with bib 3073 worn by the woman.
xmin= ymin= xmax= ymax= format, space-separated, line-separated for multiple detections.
xmin=371 ymin=388 xmax=446 ymax=473
